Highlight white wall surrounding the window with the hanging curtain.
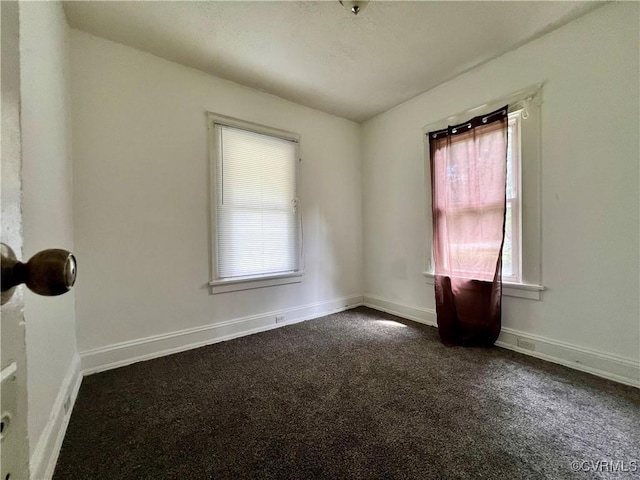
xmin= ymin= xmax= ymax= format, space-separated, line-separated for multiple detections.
xmin=362 ymin=2 xmax=640 ymax=362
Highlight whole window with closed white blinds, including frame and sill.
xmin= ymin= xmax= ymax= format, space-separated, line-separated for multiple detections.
xmin=209 ymin=114 xmax=302 ymax=293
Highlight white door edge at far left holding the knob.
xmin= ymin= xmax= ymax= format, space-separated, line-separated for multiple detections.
xmin=0 ymin=1 xmax=29 ymax=480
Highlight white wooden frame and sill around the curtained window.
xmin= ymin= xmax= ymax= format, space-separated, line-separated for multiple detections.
xmin=422 ymin=85 xmax=544 ymax=300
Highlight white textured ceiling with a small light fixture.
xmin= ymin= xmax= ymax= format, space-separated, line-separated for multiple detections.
xmin=65 ymin=1 xmax=602 ymax=122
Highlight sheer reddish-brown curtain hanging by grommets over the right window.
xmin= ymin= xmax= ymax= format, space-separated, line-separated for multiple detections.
xmin=428 ymin=106 xmax=508 ymax=346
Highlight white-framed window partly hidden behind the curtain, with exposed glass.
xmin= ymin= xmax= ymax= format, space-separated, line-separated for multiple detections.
xmin=423 ymin=86 xmax=543 ymax=299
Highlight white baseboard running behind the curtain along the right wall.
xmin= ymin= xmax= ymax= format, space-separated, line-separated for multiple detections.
xmin=363 ymin=294 xmax=640 ymax=388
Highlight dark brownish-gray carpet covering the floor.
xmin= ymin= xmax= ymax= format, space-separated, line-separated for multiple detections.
xmin=54 ymin=308 xmax=640 ymax=480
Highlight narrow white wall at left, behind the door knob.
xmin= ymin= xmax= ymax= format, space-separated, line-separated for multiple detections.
xmin=20 ymin=2 xmax=76 ymax=464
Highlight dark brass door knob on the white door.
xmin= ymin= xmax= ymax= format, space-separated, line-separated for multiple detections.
xmin=0 ymin=243 xmax=77 ymax=305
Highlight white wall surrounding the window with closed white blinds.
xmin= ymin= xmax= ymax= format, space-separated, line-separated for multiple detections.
xmin=71 ymin=30 xmax=362 ymax=351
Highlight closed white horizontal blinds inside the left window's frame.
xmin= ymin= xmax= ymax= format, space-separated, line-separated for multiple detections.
xmin=216 ymin=126 xmax=300 ymax=278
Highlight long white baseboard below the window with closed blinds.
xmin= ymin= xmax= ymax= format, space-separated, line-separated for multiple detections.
xmin=80 ymin=295 xmax=362 ymax=375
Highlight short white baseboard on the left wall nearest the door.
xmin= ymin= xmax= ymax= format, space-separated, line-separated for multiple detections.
xmin=29 ymin=354 xmax=82 ymax=480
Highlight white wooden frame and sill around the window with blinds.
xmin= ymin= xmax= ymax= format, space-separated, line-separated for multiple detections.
xmin=207 ymin=112 xmax=304 ymax=294
